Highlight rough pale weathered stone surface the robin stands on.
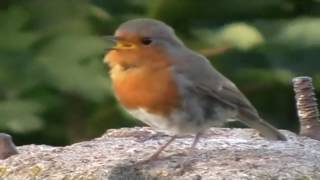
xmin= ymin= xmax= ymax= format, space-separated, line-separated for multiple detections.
xmin=0 ymin=128 xmax=320 ymax=180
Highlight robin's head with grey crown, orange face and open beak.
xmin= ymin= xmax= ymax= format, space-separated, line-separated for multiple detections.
xmin=105 ymin=19 xmax=184 ymax=70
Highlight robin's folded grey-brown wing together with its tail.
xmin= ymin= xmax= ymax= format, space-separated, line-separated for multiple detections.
xmin=175 ymin=50 xmax=286 ymax=140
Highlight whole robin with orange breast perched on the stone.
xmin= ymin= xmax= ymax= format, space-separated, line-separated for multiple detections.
xmin=104 ymin=19 xmax=286 ymax=160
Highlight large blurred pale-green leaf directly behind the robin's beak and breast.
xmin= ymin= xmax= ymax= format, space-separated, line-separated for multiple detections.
xmin=36 ymin=35 xmax=110 ymax=101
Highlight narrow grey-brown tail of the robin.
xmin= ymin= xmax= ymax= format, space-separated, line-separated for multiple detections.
xmin=239 ymin=111 xmax=287 ymax=141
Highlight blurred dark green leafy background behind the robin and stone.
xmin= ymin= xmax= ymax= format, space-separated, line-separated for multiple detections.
xmin=0 ymin=0 xmax=320 ymax=145
